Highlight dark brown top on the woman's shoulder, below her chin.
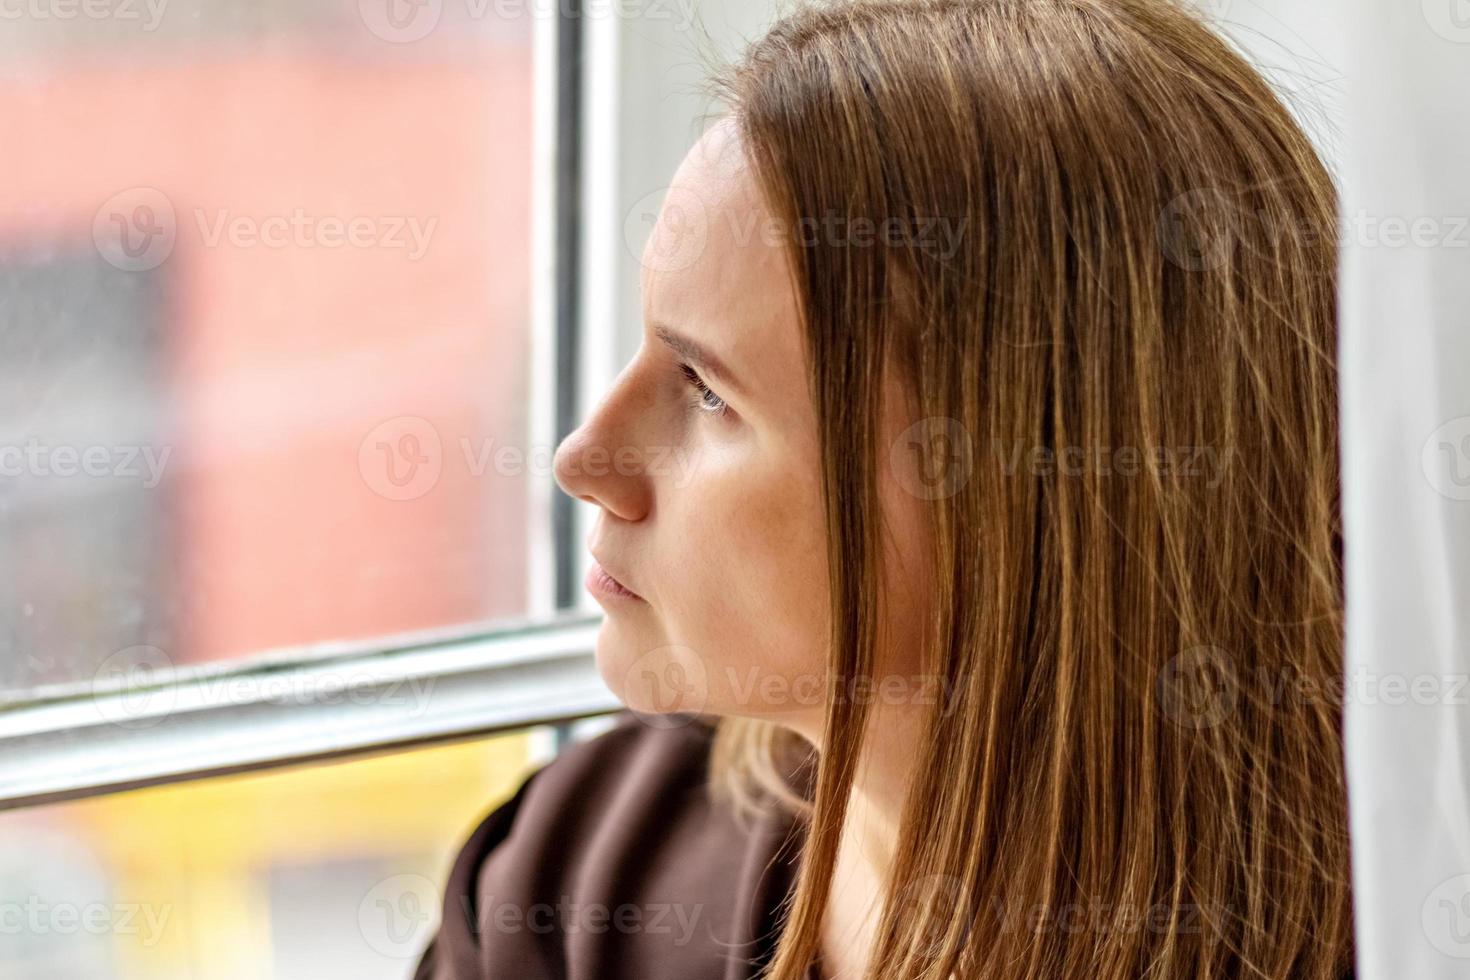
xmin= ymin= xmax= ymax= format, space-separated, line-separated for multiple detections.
xmin=413 ymin=711 xmax=801 ymax=980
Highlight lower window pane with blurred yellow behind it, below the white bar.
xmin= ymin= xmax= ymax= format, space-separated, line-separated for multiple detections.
xmin=0 ymin=729 xmax=553 ymax=980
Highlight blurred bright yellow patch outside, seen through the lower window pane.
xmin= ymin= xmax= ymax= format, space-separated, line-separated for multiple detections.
xmin=42 ymin=733 xmax=532 ymax=980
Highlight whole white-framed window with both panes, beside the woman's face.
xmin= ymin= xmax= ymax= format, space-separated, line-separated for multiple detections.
xmin=0 ymin=0 xmax=767 ymax=980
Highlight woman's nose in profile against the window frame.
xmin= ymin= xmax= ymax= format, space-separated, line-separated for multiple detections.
xmin=553 ymin=391 xmax=651 ymax=520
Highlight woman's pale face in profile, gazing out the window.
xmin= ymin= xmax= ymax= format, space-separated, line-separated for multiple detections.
xmin=556 ymin=120 xmax=923 ymax=739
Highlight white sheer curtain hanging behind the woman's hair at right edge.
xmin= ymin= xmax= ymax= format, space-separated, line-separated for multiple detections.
xmin=1338 ymin=0 xmax=1470 ymax=980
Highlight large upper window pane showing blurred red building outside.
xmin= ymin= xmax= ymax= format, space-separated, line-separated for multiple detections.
xmin=0 ymin=0 xmax=548 ymax=696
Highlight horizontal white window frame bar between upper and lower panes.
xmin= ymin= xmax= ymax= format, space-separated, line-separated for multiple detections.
xmin=0 ymin=614 xmax=617 ymax=810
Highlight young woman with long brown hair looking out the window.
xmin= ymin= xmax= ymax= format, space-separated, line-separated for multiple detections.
xmin=419 ymin=0 xmax=1352 ymax=980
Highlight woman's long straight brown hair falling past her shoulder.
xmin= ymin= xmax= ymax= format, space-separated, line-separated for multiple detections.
xmin=699 ymin=0 xmax=1352 ymax=980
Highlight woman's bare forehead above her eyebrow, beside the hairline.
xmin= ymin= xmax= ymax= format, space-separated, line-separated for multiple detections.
xmin=642 ymin=120 xmax=804 ymax=391
